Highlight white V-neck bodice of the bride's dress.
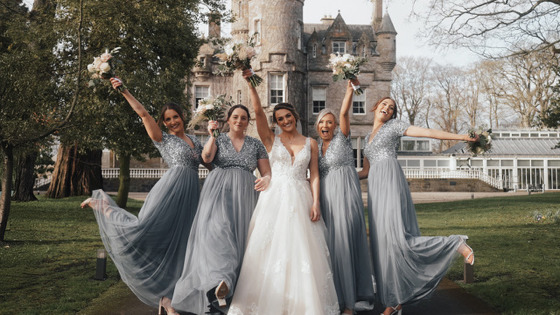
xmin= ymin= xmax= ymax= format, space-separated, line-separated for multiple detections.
xmin=269 ymin=137 xmax=311 ymax=180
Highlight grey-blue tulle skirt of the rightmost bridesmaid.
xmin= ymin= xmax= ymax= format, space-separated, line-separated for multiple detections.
xmin=368 ymin=158 xmax=466 ymax=306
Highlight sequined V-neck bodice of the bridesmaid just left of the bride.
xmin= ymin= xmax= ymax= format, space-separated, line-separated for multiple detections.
xmin=212 ymin=133 xmax=268 ymax=172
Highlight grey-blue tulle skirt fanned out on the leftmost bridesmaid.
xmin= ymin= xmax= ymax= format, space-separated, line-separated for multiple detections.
xmin=91 ymin=167 xmax=199 ymax=307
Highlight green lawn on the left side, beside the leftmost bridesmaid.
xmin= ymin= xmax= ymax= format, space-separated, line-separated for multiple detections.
xmin=0 ymin=197 xmax=142 ymax=314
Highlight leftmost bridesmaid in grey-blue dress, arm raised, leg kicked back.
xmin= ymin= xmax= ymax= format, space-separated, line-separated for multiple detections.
xmin=81 ymin=78 xmax=202 ymax=314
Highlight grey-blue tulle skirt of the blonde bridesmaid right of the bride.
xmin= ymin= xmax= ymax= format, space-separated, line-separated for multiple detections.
xmin=320 ymin=166 xmax=374 ymax=310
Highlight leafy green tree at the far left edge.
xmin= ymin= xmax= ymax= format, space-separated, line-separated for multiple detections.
xmin=0 ymin=0 xmax=81 ymax=241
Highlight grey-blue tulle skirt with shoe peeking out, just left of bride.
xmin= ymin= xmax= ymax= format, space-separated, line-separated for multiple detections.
xmin=172 ymin=168 xmax=259 ymax=314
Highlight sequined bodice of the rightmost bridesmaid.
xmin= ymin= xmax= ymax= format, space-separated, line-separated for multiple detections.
xmin=364 ymin=119 xmax=410 ymax=163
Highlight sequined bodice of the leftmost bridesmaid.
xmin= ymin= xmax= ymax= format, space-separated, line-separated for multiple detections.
xmin=154 ymin=132 xmax=202 ymax=170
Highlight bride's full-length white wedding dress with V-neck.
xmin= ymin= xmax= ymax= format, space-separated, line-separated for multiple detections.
xmin=228 ymin=137 xmax=340 ymax=315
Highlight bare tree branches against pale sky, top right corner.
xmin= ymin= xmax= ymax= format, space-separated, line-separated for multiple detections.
xmin=414 ymin=0 xmax=560 ymax=56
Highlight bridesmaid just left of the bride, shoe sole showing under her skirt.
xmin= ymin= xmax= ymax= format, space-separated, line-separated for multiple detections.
xmin=172 ymin=105 xmax=270 ymax=314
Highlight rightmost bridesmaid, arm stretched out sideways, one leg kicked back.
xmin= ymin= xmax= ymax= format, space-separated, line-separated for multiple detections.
xmin=359 ymin=97 xmax=478 ymax=315
